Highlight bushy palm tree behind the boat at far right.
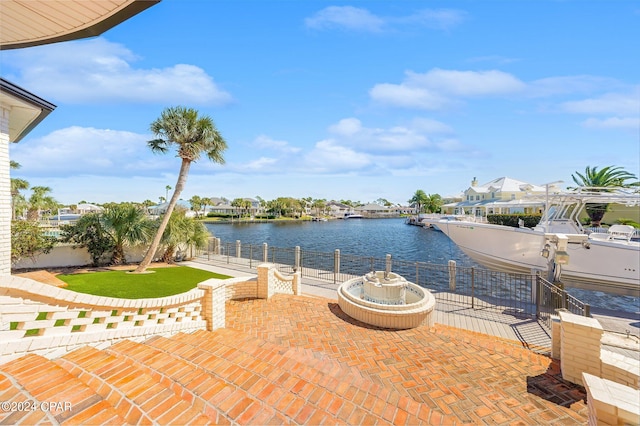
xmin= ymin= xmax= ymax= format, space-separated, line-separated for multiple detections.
xmin=570 ymin=166 xmax=640 ymax=227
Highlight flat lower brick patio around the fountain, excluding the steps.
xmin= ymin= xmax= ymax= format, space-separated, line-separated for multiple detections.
xmin=227 ymin=295 xmax=587 ymax=424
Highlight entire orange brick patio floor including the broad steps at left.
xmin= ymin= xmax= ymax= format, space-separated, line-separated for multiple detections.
xmin=0 ymin=295 xmax=587 ymax=425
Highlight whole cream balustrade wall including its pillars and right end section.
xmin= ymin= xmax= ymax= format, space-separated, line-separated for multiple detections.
xmin=0 ymin=264 xmax=300 ymax=364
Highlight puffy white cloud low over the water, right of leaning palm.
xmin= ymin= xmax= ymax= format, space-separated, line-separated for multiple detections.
xmin=232 ymin=117 xmax=464 ymax=178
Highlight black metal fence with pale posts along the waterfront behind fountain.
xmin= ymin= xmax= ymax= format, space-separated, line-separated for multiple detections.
xmin=199 ymin=238 xmax=590 ymax=329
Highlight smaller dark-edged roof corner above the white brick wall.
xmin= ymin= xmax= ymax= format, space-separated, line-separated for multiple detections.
xmin=0 ymin=77 xmax=56 ymax=142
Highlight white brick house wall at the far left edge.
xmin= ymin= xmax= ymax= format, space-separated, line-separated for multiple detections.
xmin=0 ymin=106 xmax=11 ymax=276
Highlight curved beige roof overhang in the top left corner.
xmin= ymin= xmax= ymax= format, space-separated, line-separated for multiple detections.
xmin=0 ymin=0 xmax=160 ymax=50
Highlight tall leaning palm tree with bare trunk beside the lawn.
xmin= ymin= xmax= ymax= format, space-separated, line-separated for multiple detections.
xmin=135 ymin=107 xmax=227 ymax=273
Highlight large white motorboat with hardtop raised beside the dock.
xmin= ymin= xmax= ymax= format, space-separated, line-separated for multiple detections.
xmin=437 ymin=188 xmax=640 ymax=297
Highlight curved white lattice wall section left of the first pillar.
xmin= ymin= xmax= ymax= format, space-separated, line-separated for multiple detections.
xmin=0 ymin=276 xmax=206 ymax=362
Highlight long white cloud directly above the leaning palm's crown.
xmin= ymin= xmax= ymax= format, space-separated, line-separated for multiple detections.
xmin=5 ymin=38 xmax=232 ymax=105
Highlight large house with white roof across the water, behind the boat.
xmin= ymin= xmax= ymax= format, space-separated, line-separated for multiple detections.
xmin=442 ymin=177 xmax=556 ymax=217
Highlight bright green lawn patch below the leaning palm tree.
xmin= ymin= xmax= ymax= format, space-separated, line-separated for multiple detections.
xmin=57 ymin=266 xmax=230 ymax=299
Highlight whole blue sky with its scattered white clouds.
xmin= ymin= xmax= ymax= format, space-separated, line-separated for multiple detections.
xmin=0 ymin=0 xmax=640 ymax=204
